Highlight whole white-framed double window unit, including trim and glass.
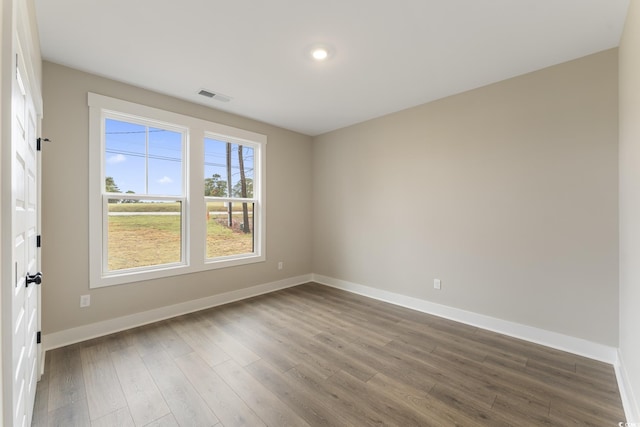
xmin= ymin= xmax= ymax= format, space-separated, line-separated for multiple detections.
xmin=89 ymin=93 xmax=266 ymax=288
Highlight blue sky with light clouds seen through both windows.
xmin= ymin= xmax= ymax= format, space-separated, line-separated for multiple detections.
xmin=105 ymin=119 xmax=254 ymax=196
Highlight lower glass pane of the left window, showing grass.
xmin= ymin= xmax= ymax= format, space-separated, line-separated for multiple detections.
xmin=107 ymin=200 xmax=182 ymax=271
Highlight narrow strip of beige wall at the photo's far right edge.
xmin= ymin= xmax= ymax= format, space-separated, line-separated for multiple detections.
xmin=620 ymin=1 xmax=640 ymax=422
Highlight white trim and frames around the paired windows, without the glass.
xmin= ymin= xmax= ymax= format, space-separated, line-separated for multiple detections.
xmin=88 ymin=92 xmax=267 ymax=288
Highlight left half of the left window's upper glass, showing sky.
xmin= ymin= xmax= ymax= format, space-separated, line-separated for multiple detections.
xmin=104 ymin=119 xmax=146 ymax=194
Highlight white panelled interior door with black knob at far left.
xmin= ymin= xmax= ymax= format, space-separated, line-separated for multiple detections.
xmin=11 ymin=45 xmax=40 ymax=426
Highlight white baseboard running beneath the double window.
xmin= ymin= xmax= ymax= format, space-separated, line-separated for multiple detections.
xmin=42 ymin=274 xmax=311 ymax=351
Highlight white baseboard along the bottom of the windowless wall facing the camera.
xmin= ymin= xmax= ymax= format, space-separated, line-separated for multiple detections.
xmin=312 ymin=274 xmax=618 ymax=365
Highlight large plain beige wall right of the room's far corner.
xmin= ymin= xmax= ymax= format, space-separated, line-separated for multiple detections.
xmin=313 ymin=49 xmax=618 ymax=346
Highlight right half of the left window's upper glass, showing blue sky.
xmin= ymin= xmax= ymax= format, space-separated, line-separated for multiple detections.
xmin=149 ymin=128 xmax=183 ymax=196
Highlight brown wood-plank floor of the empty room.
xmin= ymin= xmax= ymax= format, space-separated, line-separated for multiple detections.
xmin=33 ymin=284 xmax=624 ymax=427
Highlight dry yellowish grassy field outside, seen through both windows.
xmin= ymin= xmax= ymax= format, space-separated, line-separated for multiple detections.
xmin=107 ymin=202 xmax=253 ymax=271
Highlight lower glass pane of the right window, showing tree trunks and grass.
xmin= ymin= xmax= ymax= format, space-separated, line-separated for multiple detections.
xmin=207 ymin=202 xmax=254 ymax=258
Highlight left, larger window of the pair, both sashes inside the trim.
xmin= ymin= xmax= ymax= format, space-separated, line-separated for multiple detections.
xmin=102 ymin=112 xmax=187 ymax=273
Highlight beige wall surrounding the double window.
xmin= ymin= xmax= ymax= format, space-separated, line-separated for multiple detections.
xmin=42 ymin=62 xmax=311 ymax=335
